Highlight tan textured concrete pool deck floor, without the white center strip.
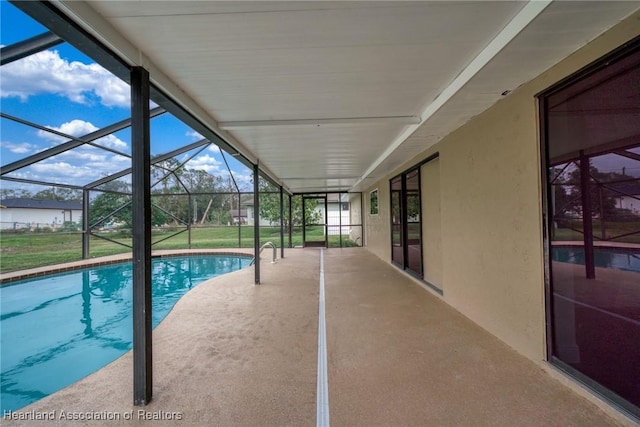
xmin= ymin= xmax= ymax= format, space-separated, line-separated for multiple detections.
xmin=2 ymin=248 xmax=634 ymax=427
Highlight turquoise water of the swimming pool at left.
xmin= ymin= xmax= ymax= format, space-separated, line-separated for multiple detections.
xmin=0 ymin=255 xmax=251 ymax=413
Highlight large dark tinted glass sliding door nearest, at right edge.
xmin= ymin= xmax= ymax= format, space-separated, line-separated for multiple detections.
xmin=540 ymin=41 xmax=640 ymax=416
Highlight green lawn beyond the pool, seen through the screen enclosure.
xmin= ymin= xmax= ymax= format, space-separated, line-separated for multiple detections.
xmin=0 ymin=226 xmax=357 ymax=273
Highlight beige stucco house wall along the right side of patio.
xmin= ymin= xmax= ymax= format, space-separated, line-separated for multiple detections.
xmin=365 ymin=13 xmax=640 ymax=361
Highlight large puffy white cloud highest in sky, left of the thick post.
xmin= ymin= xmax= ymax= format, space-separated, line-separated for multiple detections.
xmin=0 ymin=50 xmax=130 ymax=107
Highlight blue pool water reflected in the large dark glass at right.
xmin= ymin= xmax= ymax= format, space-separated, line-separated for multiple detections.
xmin=551 ymin=247 xmax=640 ymax=272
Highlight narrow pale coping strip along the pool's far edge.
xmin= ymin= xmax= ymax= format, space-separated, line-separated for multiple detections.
xmin=0 ymin=248 xmax=253 ymax=286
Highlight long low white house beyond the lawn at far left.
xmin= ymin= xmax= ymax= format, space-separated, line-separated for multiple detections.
xmin=0 ymin=198 xmax=82 ymax=230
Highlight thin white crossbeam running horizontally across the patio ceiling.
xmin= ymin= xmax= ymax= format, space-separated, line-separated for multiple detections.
xmin=218 ymin=116 xmax=420 ymax=130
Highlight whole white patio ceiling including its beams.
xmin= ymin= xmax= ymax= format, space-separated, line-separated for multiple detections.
xmin=55 ymin=1 xmax=639 ymax=192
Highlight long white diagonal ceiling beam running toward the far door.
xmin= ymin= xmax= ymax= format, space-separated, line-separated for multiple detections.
xmin=353 ymin=0 xmax=552 ymax=191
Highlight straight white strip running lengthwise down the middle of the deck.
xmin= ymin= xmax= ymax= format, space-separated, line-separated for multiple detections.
xmin=316 ymin=248 xmax=329 ymax=427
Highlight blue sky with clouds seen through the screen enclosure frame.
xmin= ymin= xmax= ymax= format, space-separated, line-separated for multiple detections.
xmin=0 ymin=0 xmax=251 ymax=192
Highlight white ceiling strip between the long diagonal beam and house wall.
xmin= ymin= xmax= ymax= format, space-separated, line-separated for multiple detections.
xmin=354 ymin=1 xmax=640 ymax=190
